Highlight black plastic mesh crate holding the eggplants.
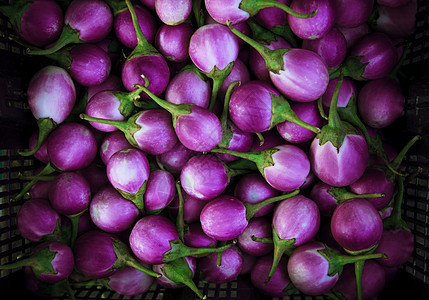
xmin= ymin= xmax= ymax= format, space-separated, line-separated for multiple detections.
xmin=0 ymin=0 xmax=429 ymax=300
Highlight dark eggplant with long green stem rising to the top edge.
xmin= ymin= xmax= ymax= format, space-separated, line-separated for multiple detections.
xmin=121 ymin=0 xmax=170 ymax=99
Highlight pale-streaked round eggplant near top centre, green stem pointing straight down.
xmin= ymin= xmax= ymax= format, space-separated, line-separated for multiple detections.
xmin=189 ymin=24 xmax=239 ymax=110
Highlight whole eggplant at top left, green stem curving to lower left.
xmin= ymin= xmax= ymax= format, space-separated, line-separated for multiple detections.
xmin=27 ymin=0 xmax=113 ymax=55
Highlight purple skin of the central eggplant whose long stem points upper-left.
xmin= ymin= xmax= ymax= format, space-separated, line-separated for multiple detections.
xmin=176 ymin=105 xmax=222 ymax=152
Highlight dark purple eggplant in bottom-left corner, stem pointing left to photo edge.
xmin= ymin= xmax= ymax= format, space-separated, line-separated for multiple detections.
xmin=0 ymin=241 xmax=74 ymax=283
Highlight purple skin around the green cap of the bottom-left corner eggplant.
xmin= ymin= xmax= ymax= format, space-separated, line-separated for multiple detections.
xmin=33 ymin=241 xmax=74 ymax=283
